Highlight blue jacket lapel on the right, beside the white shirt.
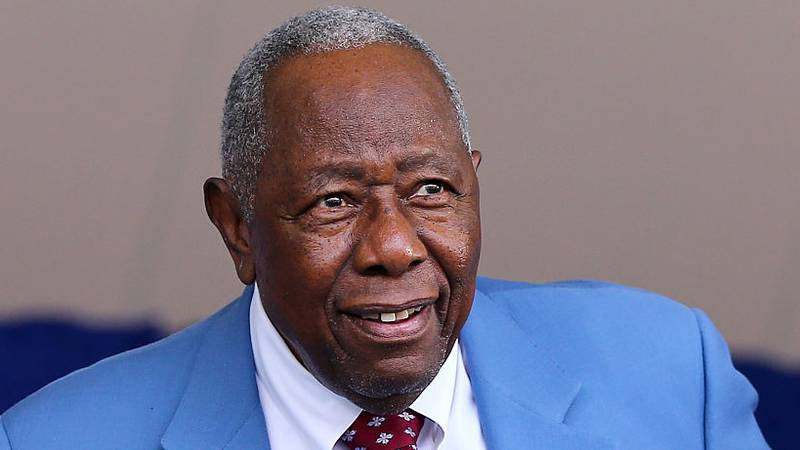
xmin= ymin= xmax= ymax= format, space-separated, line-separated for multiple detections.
xmin=460 ymin=291 xmax=614 ymax=450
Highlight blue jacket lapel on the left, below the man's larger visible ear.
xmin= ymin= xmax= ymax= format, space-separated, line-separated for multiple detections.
xmin=161 ymin=286 xmax=269 ymax=450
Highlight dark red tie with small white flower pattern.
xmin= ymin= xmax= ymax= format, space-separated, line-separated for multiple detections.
xmin=342 ymin=409 xmax=424 ymax=450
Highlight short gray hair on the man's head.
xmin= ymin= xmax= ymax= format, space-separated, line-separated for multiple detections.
xmin=220 ymin=6 xmax=472 ymax=222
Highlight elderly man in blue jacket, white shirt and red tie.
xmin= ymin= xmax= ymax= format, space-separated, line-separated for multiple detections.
xmin=0 ymin=7 xmax=766 ymax=450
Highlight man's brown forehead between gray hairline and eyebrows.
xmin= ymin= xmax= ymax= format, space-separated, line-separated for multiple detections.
xmin=264 ymin=44 xmax=465 ymax=163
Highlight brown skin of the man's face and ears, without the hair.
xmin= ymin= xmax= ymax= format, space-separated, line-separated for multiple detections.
xmin=204 ymin=45 xmax=480 ymax=414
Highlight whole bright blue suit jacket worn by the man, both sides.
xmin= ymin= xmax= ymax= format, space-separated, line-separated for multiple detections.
xmin=0 ymin=278 xmax=767 ymax=450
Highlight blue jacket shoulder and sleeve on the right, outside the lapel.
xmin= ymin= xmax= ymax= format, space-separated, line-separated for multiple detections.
xmin=476 ymin=279 xmax=768 ymax=449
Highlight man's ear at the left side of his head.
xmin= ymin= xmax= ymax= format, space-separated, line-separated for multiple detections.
xmin=203 ymin=178 xmax=256 ymax=284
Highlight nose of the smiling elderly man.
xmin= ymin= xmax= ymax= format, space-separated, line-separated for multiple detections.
xmin=354 ymin=201 xmax=428 ymax=276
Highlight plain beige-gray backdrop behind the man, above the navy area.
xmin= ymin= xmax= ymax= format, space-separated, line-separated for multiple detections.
xmin=0 ymin=0 xmax=800 ymax=365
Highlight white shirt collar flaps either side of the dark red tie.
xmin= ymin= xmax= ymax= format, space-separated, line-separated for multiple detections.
xmin=250 ymin=284 xmax=461 ymax=448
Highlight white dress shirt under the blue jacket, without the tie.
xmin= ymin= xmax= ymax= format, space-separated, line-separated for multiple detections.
xmin=250 ymin=285 xmax=486 ymax=450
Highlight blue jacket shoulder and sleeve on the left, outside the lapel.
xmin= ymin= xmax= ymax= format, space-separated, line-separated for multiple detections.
xmin=2 ymin=300 xmax=227 ymax=449
